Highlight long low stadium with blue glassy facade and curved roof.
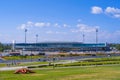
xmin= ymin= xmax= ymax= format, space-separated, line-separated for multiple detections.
xmin=15 ymin=42 xmax=111 ymax=52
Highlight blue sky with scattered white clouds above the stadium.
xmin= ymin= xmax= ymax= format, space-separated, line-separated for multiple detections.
xmin=0 ymin=0 xmax=120 ymax=43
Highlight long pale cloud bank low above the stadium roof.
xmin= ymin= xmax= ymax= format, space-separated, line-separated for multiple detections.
xmin=15 ymin=19 xmax=120 ymax=42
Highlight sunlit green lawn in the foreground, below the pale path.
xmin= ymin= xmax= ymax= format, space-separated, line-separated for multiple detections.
xmin=0 ymin=65 xmax=120 ymax=80
